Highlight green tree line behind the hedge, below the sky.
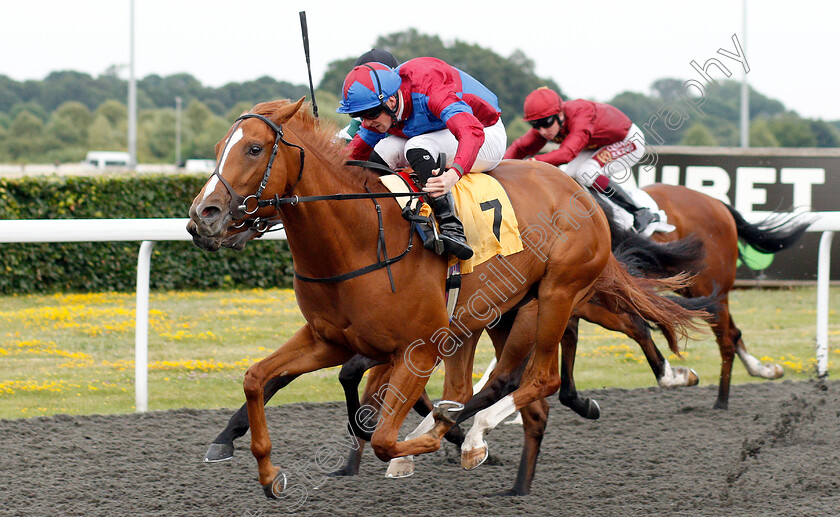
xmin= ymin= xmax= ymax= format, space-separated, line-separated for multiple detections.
xmin=0 ymin=29 xmax=840 ymax=163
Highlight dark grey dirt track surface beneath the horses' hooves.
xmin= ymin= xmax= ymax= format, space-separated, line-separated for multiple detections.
xmin=0 ymin=381 xmax=840 ymax=517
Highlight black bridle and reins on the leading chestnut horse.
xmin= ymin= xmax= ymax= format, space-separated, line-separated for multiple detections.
xmin=213 ymin=113 xmax=425 ymax=292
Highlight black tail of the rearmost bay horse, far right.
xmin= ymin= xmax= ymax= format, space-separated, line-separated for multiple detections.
xmin=725 ymin=204 xmax=813 ymax=253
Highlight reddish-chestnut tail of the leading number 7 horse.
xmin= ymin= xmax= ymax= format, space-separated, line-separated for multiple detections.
xmin=594 ymin=255 xmax=711 ymax=355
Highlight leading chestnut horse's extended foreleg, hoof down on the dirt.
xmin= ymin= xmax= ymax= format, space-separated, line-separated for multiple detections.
xmin=243 ymin=325 xmax=353 ymax=498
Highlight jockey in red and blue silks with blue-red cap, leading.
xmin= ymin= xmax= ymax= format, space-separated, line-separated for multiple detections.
xmin=336 ymin=57 xmax=507 ymax=260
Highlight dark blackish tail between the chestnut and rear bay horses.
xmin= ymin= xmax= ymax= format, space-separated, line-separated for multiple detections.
xmin=596 ymin=190 xmax=705 ymax=277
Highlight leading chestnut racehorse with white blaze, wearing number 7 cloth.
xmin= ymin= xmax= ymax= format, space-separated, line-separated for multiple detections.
xmin=187 ymin=99 xmax=700 ymax=497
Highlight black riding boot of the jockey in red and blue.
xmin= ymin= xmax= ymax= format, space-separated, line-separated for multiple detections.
xmin=405 ymin=149 xmax=473 ymax=260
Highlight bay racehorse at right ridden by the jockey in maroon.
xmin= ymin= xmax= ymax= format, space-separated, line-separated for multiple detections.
xmin=561 ymin=184 xmax=811 ymax=409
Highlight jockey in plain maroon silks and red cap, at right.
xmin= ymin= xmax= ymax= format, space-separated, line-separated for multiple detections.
xmin=505 ymin=87 xmax=659 ymax=232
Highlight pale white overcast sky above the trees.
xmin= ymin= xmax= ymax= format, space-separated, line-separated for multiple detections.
xmin=0 ymin=0 xmax=840 ymax=120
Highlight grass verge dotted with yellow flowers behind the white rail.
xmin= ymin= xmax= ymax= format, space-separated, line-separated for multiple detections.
xmin=0 ymin=288 xmax=840 ymax=418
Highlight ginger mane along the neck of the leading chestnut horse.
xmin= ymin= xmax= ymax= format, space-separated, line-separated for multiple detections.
xmin=251 ymin=99 xmax=377 ymax=187
